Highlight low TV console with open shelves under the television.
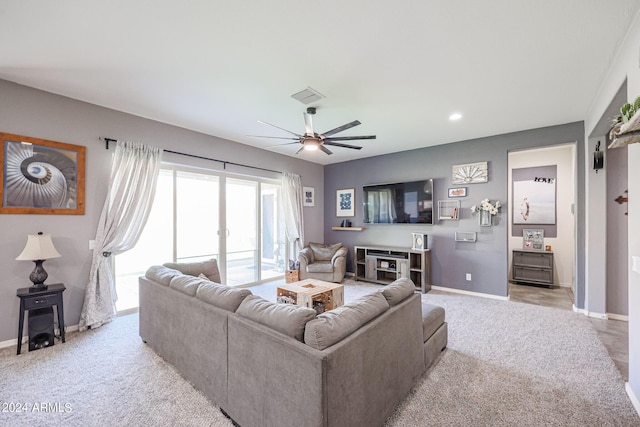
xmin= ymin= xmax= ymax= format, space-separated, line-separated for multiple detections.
xmin=354 ymin=246 xmax=431 ymax=293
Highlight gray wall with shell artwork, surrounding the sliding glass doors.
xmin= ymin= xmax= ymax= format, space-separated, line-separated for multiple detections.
xmin=0 ymin=80 xmax=323 ymax=342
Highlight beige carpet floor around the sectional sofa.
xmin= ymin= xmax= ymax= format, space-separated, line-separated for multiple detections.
xmin=0 ymin=284 xmax=640 ymax=427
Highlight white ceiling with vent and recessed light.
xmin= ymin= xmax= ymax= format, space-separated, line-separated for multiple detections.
xmin=0 ymin=0 xmax=640 ymax=164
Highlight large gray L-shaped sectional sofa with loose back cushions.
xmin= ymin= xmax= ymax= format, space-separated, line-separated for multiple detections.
xmin=139 ymin=261 xmax=447 ymax=427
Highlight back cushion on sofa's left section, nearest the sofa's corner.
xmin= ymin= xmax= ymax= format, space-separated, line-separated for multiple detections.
xmin=236 ymin=295 xmax=316 ymax=341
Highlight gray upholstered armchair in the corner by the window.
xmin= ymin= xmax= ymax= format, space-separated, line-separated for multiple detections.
xmin=298 ymin=243 xmax=348 ymax=283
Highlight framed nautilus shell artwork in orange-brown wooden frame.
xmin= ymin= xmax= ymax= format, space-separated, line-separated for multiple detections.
xmin=0 ymin=133 xmax=86 ymax=215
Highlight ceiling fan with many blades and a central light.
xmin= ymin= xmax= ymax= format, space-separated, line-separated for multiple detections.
xmin=256 ymin=107 xmax=376 ymax=154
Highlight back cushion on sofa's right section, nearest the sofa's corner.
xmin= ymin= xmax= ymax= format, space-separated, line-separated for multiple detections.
xmin=304 ymin=292 xmax=389 ymax=350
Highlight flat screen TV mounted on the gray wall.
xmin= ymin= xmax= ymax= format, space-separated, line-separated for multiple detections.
xmin=362 ymin=179 xmax=433 ymax=224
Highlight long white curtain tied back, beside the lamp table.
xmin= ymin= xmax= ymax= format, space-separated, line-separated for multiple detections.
xmin=79 ymin=141 xmax=162 ymax=331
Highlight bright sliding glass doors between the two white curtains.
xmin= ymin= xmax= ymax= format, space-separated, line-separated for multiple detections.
xmin=115 ymin=169 xmax=286 ymax=311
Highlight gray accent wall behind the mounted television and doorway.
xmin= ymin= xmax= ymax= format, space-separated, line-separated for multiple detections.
xmin=324 ymin=122 xmax=584 ymax=297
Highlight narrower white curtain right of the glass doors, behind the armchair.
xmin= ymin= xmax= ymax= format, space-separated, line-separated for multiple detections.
xmin=282 ymin=172 xmax=304 ymax=249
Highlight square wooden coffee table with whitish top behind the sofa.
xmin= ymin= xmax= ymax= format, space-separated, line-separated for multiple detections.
xmin=276 ymin=279 xmax=344 ymax=314
